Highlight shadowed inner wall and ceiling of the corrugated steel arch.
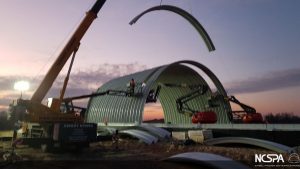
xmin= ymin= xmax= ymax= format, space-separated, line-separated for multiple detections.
xmin=155 ymin=64 xmax=211 ymax=124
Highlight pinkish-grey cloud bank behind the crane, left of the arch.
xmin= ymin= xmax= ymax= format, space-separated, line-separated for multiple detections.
xmin=0 ymin=63 xmax=147 ymax=111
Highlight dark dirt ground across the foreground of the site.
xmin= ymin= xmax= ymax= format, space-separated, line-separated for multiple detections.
xmin=0 ymin=139 xmax=290 ymax=169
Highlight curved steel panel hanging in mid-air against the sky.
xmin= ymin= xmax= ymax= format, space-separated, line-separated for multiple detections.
xmin=129 ymin=5 xmax=215 ymax=51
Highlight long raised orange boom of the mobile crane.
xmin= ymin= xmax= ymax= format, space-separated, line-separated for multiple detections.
xmin=31 ymin=0 xmax=106 ymax=103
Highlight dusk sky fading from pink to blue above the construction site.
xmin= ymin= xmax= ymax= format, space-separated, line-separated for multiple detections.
xmin=0 ymin=0 xmax=300 ymax=119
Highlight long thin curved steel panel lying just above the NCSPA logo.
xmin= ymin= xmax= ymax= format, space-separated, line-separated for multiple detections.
xmin=204 ymin=137 xmax=293 ymax=153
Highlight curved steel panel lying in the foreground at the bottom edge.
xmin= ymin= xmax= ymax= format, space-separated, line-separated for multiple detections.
xmin=166 ymin=152 xmax=250 ymax=169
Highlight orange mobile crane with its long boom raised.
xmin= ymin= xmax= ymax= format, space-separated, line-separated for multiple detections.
xmin=14 ymin=0 xmax=106 ymax=148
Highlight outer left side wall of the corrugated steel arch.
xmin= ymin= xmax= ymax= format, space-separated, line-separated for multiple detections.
xmin=86 ymin=68 xmax=156 ymax=123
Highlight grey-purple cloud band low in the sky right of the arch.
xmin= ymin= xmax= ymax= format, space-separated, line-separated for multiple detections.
xmin=224 ymin=68 xmax=300 ymax=94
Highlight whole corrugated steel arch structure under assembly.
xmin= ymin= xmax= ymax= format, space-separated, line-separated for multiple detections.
xmin=86 ymin=60 xmax=231 ymax=124
